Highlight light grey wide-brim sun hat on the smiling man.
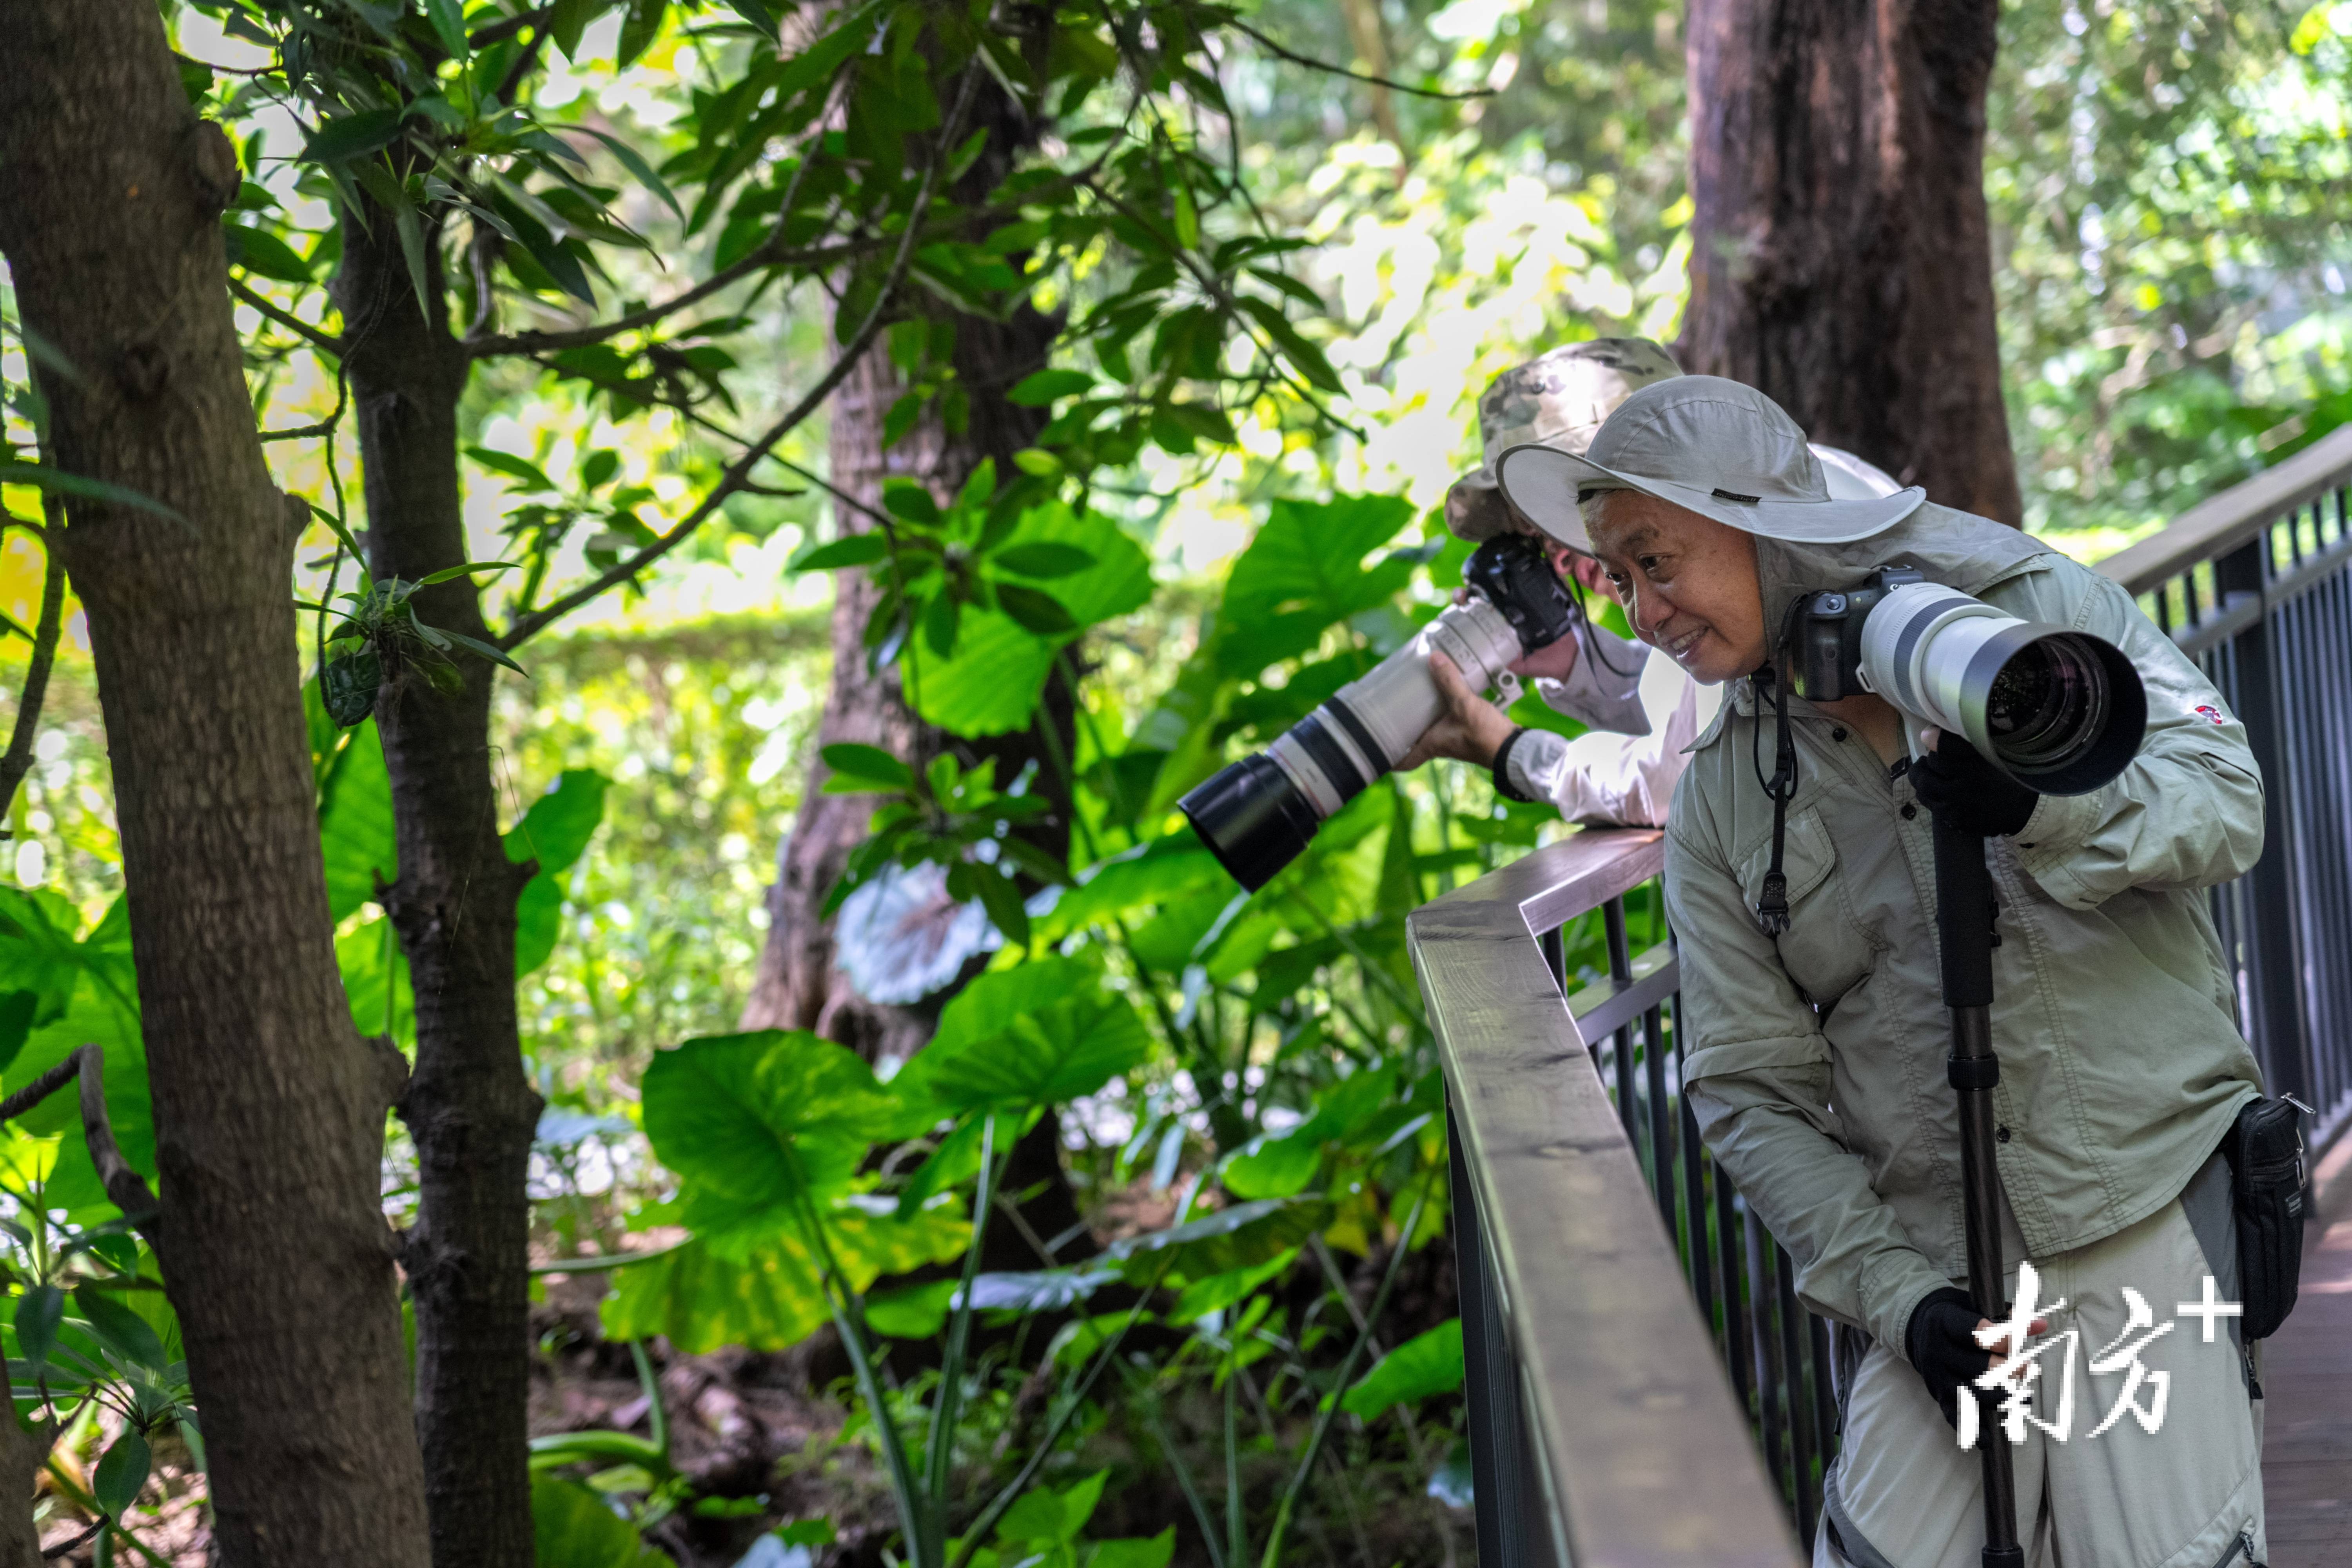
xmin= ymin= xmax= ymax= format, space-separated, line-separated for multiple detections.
xmin=1494 ymin=376 xmax=1926 ymax=552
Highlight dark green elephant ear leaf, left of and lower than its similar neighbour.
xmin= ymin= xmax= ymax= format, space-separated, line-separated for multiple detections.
xmin=644 ymin=1030 xmax=927 ymax=1213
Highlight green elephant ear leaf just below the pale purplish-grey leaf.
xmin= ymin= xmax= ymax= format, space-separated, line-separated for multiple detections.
xmin=894 ymin=959 xmax=1152 ymax=1112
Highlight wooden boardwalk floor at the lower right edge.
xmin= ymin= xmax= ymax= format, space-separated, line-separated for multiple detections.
xmin=2263 ymin=1138 xmax=2352 ymax=1568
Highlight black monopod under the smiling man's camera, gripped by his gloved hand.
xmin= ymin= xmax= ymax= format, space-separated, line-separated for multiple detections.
xmin=1936 ymin=813 xmax=2025 ymax=1568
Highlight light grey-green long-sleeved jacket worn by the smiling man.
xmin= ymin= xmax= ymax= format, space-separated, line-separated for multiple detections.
xmin=1665 ymin=505 xmax=2263 ymax=1354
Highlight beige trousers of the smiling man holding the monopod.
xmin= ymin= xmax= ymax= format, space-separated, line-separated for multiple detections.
xmin=1813 ymin=1154 xmax=2267 ymax=1568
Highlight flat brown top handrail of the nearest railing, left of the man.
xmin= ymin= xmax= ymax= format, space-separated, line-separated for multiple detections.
xmin=1406 ymin=830 xmax=1799 ymax=1568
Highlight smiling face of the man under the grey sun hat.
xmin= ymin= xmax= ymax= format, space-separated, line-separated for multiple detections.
xmin=1585 ymin=491 xmax=1769 ymax=684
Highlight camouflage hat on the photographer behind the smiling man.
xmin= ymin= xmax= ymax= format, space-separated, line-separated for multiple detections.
xmin=1446 ymin=339 xmax=1682 ymax=541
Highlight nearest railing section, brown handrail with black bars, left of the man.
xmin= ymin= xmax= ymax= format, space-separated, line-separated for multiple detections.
xmin=1406 ymin=830 xmax=1806 ymax=1568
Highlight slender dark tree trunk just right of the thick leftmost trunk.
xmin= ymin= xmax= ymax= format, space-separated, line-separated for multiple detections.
xmin=334 ymin=212 xmax=541 ymax=1568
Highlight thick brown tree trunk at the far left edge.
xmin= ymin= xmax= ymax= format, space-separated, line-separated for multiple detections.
xmin=0 ymin=0 xmax=428 ymax=1568
